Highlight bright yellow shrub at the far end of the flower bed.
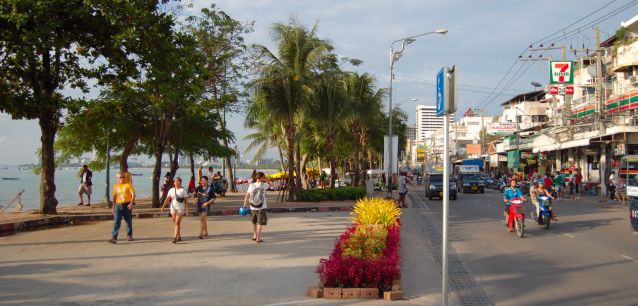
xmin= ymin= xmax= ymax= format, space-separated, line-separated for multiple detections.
xmin=351 ymin=198 xmax=401 ymax=228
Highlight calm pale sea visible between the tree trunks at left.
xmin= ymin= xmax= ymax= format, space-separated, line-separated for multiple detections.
xmin=0 ymin=166 xmax=278 ymax=211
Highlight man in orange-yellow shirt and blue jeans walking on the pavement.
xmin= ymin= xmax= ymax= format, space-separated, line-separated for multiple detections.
xmin=109 ymin=171 xmax=135 ymax=244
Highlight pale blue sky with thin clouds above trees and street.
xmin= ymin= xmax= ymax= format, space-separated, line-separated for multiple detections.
xmin=0 ymin=0 xmax=638 ymax=165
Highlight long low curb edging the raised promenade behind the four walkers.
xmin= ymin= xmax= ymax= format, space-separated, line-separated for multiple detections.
xmin=0 ymin=206 xmax=352 ymax=237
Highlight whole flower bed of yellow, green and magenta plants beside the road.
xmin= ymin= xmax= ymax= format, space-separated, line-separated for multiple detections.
xmin=316 ymin=198 xmax=401 ymax=297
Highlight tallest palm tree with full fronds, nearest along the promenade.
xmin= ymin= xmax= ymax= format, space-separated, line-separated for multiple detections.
xmin=249 ymin=20 xmax=332 ymax=201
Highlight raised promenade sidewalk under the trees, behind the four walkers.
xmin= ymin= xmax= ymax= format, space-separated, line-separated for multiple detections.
xmin=0 ymin=193 xmax=354 ymax=237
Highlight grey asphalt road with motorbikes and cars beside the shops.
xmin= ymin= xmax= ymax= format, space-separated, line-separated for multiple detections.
xmin=413 ymin=188 xmax=638 ymax=305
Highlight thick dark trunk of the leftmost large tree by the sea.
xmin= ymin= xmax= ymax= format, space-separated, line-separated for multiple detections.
xmin=38 ymin=112 xmax=58 ymax=215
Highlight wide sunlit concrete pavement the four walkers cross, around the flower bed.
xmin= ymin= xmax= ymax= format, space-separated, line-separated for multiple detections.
xmin=0 ymin=195 xmax=448 ymax=305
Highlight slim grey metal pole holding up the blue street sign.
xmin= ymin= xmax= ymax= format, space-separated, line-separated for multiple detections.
xmin=441 ymin=113 xmax=450 ymax=306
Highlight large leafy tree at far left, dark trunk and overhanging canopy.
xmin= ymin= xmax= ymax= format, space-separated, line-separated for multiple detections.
xmin=0 ymin=0 xmax=172 ymax=214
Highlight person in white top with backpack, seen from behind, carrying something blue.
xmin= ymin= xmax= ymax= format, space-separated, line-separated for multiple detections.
xmin=244 ymin=172 xmax=270 ymax=243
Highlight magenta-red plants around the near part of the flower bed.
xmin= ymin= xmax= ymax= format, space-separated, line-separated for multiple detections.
xmin=316 ymin=225 xmax=400 ymax=290
